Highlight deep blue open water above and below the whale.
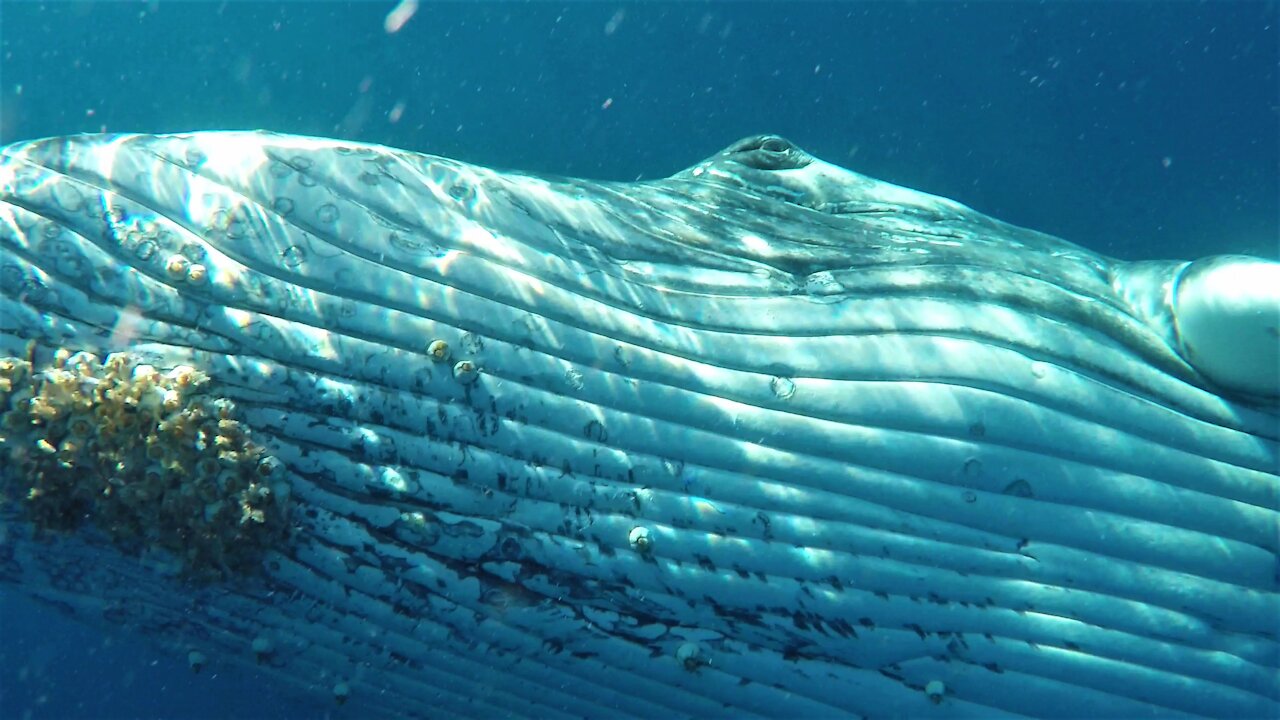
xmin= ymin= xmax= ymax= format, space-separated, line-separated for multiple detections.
xmin=0 ymin=1 xmax=1280 ymax=717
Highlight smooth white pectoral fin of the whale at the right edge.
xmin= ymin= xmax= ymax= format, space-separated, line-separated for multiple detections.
xmin=1172 ymin=255 xmax=1280 ymax=397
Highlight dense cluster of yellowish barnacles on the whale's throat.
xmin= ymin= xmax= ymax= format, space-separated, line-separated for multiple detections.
xmin=0 ymin=351 xmax=288 ymax=579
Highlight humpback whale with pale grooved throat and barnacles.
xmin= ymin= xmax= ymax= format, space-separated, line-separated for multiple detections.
xmin=0 ymin=132 xmax=1280 ymax=719
